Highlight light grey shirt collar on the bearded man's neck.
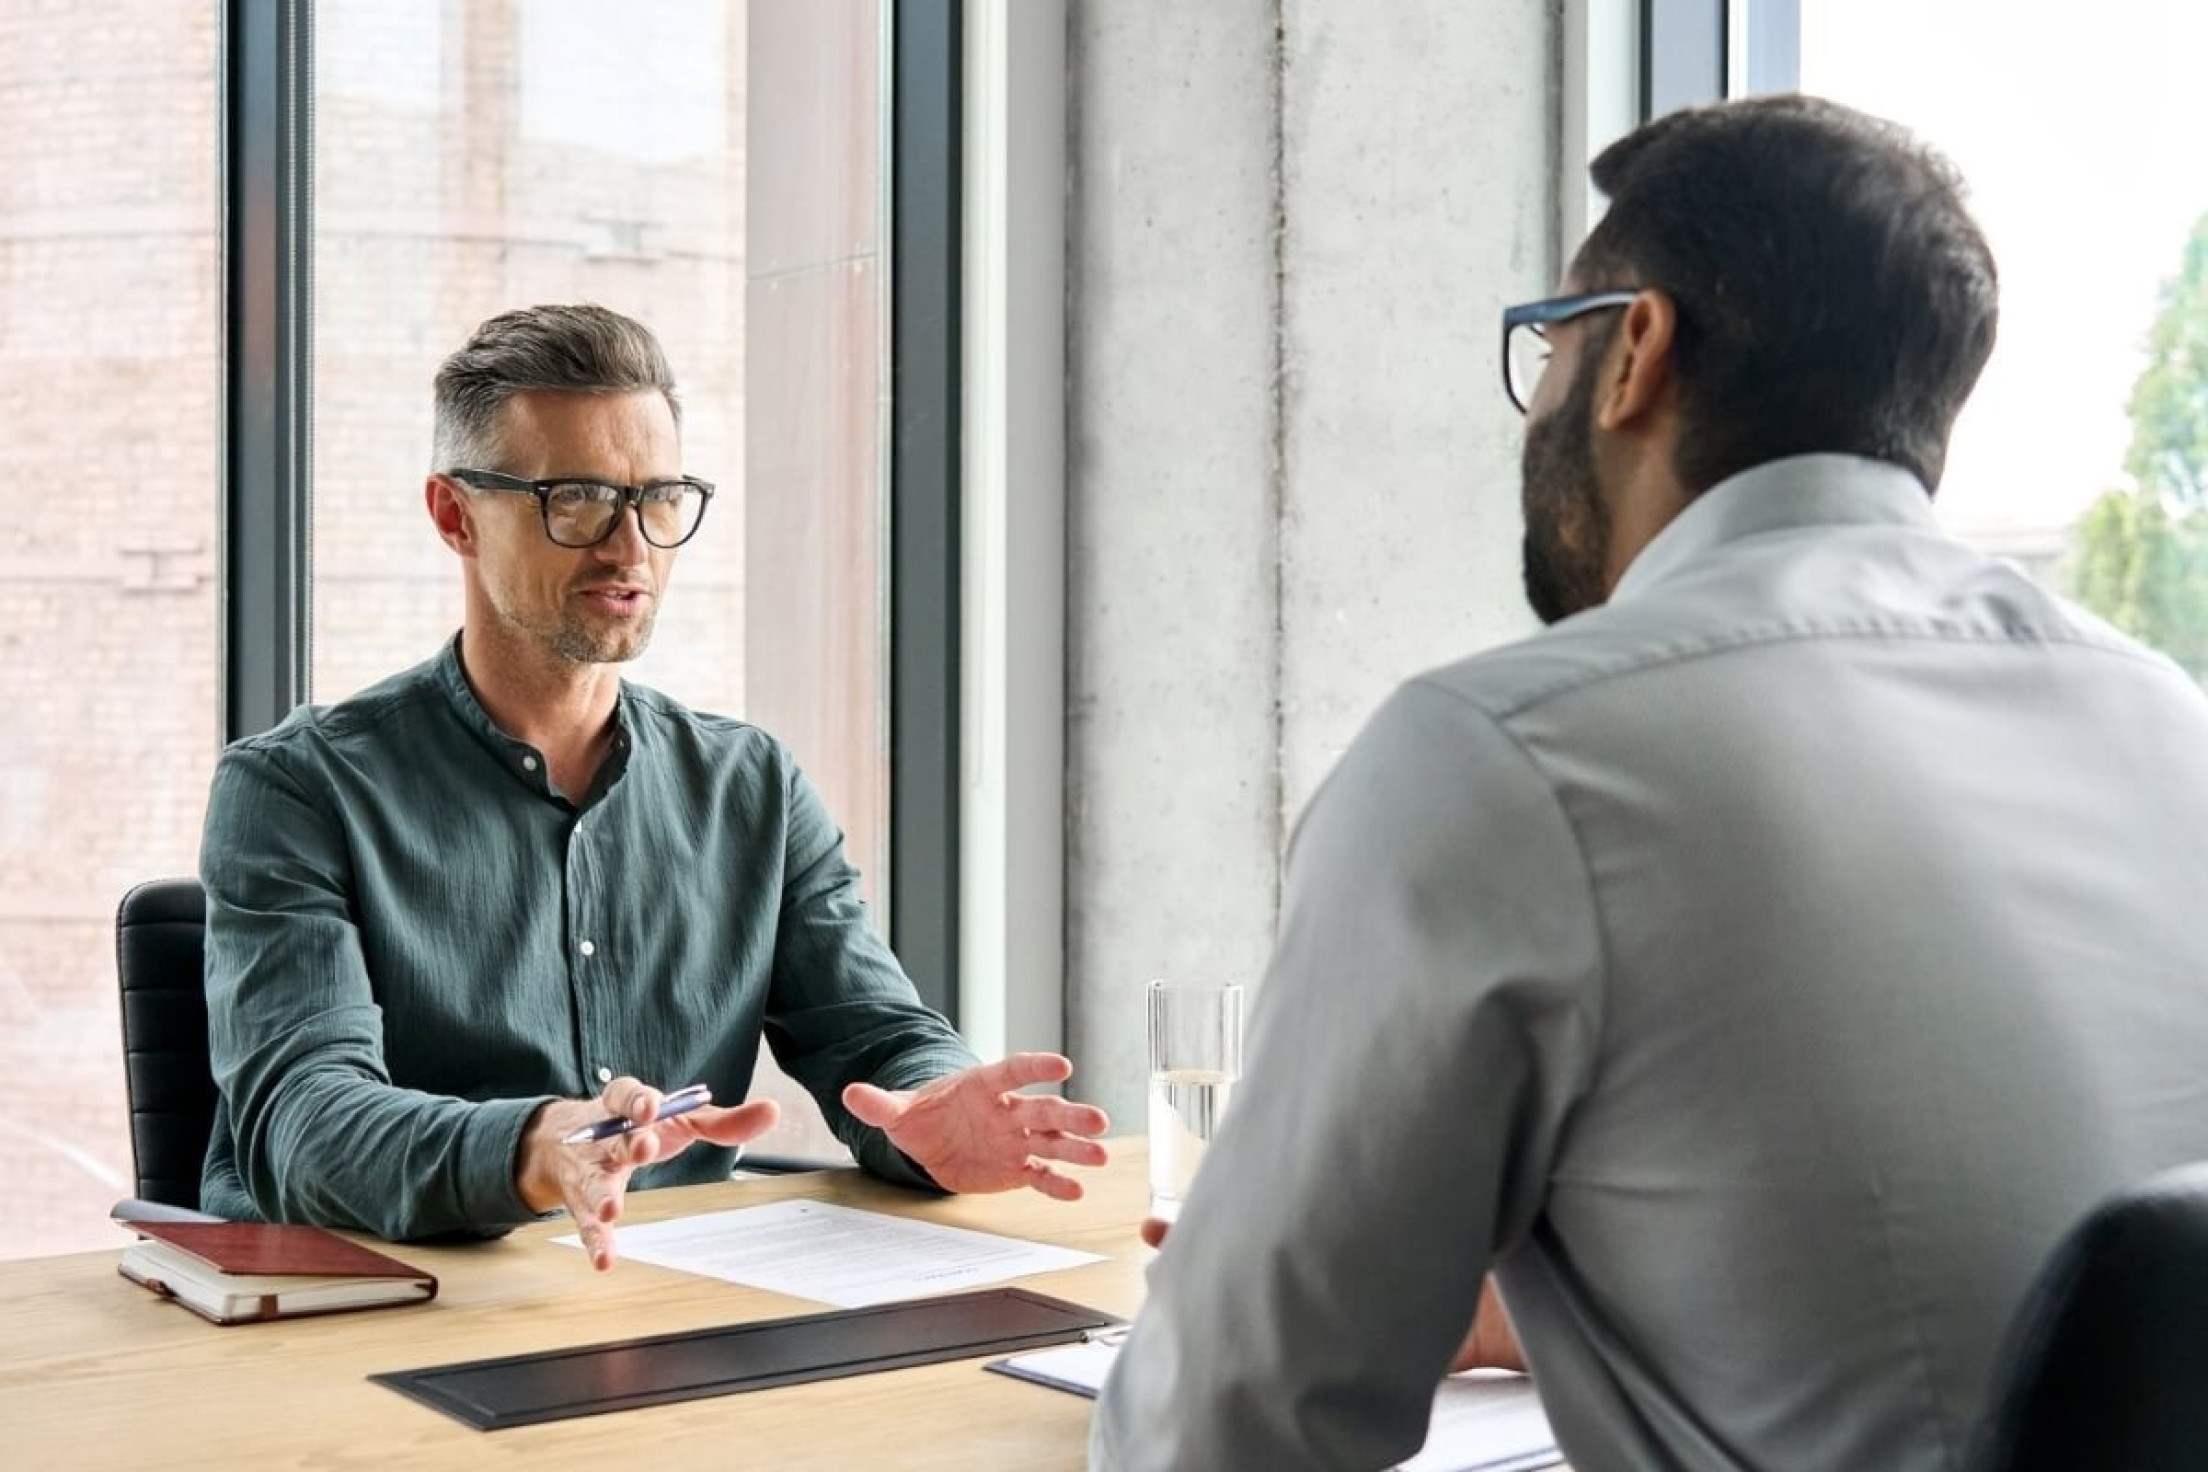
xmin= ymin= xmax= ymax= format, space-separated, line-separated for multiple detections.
xmin=1610 ymin=455 xmax=1939 ymax=602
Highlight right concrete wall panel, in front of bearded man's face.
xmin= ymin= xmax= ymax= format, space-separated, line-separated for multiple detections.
xmin=1281 ymin=0 xmax=1561 ymax=825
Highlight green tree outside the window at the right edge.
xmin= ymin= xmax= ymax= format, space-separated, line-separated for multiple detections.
xmin=2071 ymin=216 xmax=2208 ymax=680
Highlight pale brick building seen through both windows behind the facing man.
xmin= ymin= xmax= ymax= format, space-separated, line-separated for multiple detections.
xmin=0 ymin=0 xmax=885 ymax=1256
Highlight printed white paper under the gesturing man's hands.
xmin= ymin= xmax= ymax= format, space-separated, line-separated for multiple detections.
xmin=552 ymin=1201 xmax=1104 ymax=1309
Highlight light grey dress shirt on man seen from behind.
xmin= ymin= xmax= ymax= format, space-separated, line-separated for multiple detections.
xmin=1093 ymin=457 xmax=2208 ymax=1472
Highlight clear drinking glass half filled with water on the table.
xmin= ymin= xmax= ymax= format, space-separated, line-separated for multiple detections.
xmin=1150 ymin=982 xmax=1243 ymax=1223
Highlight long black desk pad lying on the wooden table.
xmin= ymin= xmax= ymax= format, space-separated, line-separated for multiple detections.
xmin=369 ymin=1289 xmax=1119 ymax=1430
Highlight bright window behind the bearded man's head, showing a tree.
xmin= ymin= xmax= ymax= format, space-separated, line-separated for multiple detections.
xmin=1802 ymin=0 xmax=2208 ymax=678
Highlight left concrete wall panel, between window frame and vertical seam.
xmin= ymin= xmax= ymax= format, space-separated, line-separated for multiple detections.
xmin=1066 ymin=0 xmax=1281 ymax=1128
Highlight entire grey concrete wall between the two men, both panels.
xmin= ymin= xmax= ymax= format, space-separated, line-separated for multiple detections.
xmin=1066 ymin=0 xmax=1563 ymax=1130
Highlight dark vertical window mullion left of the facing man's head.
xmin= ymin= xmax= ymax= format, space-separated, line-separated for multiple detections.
xmin=221 ymin=0 xmax=314 ymax=742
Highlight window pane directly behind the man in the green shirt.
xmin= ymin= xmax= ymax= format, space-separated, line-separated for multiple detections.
xmin=314 ymin=0 xmax=888 ymax=1150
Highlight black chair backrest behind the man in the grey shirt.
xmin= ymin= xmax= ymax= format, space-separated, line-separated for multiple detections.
xmin=1974 ymin=1165 xmax=2208 ymax=1472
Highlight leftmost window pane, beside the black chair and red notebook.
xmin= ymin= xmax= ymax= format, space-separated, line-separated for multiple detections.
xmin=0 ymin=0 xmax=221 ymax=1256
